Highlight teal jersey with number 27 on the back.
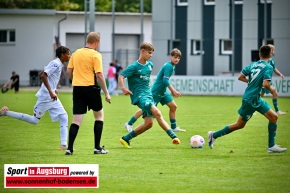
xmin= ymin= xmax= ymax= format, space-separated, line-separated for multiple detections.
xmin=241 ymin=60 xmax=273 ymax=108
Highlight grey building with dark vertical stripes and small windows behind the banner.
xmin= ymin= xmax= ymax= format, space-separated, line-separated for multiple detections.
xmin=152 ymin=0 xmax=290 ymax=76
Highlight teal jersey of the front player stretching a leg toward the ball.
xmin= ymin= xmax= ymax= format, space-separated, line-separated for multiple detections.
xmin=121 ymin=60 xmax=153 ymax=105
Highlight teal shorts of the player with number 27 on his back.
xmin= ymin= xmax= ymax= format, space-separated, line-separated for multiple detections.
xmin=238 ymin=99 xmax=271 ymax=122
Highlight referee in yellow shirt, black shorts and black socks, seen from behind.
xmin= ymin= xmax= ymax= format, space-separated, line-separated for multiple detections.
xmin=65 ymin=32 xmax=111 ymax=155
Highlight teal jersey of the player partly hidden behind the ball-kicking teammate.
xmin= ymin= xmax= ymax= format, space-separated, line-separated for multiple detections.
xmin=151 ymin=62 xmax=175 ymax=96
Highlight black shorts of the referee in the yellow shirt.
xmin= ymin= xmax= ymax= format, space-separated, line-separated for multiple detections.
xmin=73 ymin=86 xmax=103 ymax=115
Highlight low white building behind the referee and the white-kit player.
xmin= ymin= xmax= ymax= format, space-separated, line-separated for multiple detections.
xmin=0 ymin=9 xmax=152 ymax=86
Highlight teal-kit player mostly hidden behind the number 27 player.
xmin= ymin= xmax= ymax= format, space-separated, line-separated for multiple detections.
xmin=261 ymin=44 xmax=286 ymax=115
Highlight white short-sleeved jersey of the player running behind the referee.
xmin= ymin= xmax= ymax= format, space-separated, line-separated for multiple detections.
xmin=35 ymin=58 xmax=63 ymax=101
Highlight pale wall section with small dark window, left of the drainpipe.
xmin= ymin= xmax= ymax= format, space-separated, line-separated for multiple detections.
xmin=0 ymin=10 xmax=54 ymax=85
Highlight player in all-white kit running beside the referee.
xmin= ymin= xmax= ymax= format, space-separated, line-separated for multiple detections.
xmin=0 ymin=46 xmax=70 ymax=149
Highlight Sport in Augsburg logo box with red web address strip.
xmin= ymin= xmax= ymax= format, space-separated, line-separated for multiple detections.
xmin=4 ymin=164 xmax=99 ymax=188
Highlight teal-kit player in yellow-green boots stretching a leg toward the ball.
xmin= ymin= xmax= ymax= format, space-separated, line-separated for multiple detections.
xmin=119 ymin=42 xmax=180 ymax=148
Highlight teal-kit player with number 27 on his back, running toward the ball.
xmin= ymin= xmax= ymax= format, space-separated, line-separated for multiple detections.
xmin=208 ymin=46 xmax=287 ymax=153
